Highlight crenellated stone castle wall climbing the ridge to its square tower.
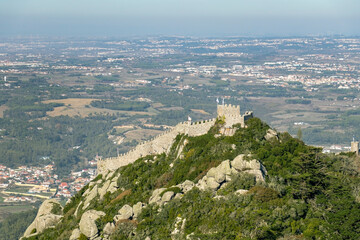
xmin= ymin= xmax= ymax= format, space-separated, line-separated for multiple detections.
xmin=97 ymin=104 xmax=253 ymax=174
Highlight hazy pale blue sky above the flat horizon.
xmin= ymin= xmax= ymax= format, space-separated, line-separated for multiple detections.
xmin=0 ymin=0 xmax=360 ymax=36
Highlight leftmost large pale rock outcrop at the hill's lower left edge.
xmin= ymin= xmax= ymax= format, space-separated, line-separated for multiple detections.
xmin=24 ymin=199 xmax=62 ymax=237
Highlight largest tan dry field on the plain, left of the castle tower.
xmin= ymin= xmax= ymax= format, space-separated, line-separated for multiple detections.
xmin=43 ymin=98 xmax=154 ymax=117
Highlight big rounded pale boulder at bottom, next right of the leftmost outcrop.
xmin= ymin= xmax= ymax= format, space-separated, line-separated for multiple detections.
xmin=79 ymin=210 xmax=105 ymax=238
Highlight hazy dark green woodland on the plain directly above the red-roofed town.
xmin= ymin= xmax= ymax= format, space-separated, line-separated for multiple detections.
xmin=0 ymin=116 xmax=116 ymax=174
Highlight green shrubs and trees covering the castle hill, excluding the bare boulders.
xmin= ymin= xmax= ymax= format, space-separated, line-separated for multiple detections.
xmin=26 ymin=118 xmax=360 ymax=239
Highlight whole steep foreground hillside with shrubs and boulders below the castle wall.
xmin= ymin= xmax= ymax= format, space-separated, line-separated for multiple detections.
xmin=22 ymin=118 xmax=360 ymax=239
